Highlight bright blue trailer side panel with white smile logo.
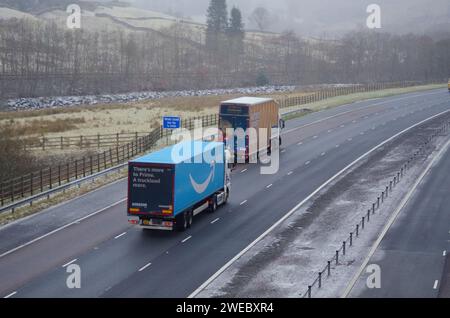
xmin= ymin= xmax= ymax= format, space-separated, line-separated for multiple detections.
xmin=174 ymin=144 xmax=225 ymax=216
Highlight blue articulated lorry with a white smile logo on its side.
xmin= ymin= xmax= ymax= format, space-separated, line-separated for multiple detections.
xmin=128 ymin=141 xmax=231 ymax=231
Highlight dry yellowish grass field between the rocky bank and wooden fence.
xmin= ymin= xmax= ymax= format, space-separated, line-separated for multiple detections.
xmin=0 ymin=92 xmax=310 ymax=138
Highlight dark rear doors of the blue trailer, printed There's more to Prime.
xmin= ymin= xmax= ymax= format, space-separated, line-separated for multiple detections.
xmin=128 ymin=163 xmax=175 ymax=214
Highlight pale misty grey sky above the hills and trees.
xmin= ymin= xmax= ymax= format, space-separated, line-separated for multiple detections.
xmin=128 ymin=0 xmax=450 ymax=35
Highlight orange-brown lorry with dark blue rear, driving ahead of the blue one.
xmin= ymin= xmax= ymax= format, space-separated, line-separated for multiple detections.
xmin=219 ymin=97 xmax=284 ymax=163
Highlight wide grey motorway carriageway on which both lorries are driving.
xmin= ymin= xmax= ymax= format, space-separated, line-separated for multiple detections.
xmin=0 ymin=89 xmax=450 ymax=297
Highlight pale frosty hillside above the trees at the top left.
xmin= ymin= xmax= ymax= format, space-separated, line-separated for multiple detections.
xmin=0 ymin=0 xmax=273 ymax=43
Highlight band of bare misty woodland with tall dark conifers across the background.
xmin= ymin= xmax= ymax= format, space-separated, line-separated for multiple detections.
xmin=0 ymin=0 xmax=450 ymax=99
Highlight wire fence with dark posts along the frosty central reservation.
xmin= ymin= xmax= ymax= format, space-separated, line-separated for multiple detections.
xmin=300 ymin=121 xmax=450 ymax=298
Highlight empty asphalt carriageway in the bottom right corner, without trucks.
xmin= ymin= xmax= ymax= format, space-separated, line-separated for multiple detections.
xmin=350 ymin=137 xmax=450 ymax=298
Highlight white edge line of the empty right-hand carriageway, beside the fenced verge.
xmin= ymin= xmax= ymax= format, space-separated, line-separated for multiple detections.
xmin=341 ymin=135 xmax=450 ymax=298
